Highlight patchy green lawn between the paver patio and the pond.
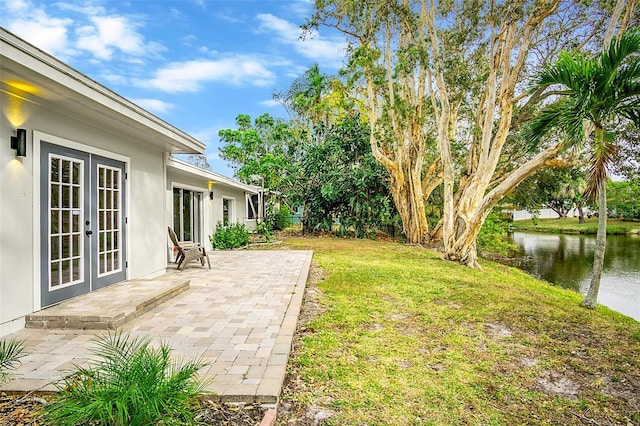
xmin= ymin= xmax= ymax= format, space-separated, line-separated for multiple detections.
xmin=280 ymin=238 xmax=640 ymax=425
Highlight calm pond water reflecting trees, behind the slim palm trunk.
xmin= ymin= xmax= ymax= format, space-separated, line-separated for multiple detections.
xmin=510 ymin=232 xmax=640 ymax=321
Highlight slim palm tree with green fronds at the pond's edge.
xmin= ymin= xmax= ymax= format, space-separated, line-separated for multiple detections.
xmin=525 ymin=30 xmax=640 ymax=309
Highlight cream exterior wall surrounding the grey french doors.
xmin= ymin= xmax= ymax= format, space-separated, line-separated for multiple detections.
xmin=0 ymin=92 xmax=166 ymax=336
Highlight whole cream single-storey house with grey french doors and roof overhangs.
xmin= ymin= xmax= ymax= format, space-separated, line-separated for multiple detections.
xmin=0 ymin=28 xmax=258 ymax=336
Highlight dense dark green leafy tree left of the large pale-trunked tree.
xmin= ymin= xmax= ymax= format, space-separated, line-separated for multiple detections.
xmin=299 ymin=114 xmax=397 ymax=238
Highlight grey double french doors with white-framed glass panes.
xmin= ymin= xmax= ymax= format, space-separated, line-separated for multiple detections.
xmin=40 ymin=142 xmax=126 ymax=307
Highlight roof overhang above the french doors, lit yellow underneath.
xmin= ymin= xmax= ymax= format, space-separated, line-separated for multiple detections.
xmin=0 ymin=27 xmax=205 ymax=154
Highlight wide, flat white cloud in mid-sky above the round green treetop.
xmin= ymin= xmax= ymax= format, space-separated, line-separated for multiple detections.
xmin=140 ymin=56 xmax=276 ymax=93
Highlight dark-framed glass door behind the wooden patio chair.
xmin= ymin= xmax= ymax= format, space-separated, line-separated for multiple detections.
xmin=173 ymin=188 xmax=202 ymax=242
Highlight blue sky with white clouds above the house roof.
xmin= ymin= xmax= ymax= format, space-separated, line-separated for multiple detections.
xmin=0 ymin=0 xmax=346 ymax=176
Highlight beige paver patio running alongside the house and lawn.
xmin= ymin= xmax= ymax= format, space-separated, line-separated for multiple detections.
xmin=0 ymin=250 xmax=312 ymax=403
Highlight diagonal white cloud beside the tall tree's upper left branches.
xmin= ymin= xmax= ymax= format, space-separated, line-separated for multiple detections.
xmin=257 ymin=13 xmax=347 ymax=68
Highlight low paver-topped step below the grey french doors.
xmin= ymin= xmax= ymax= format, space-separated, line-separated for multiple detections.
xmin=25 ymin=275 xmax=189 ymax=330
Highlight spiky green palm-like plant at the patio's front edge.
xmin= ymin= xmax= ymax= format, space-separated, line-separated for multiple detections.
xmin=44 ymin=333 xmax=205 ymax=426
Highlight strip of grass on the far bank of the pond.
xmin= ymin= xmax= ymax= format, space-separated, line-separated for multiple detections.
xmin=510 ymin=217 xmax=640 ymax=235
